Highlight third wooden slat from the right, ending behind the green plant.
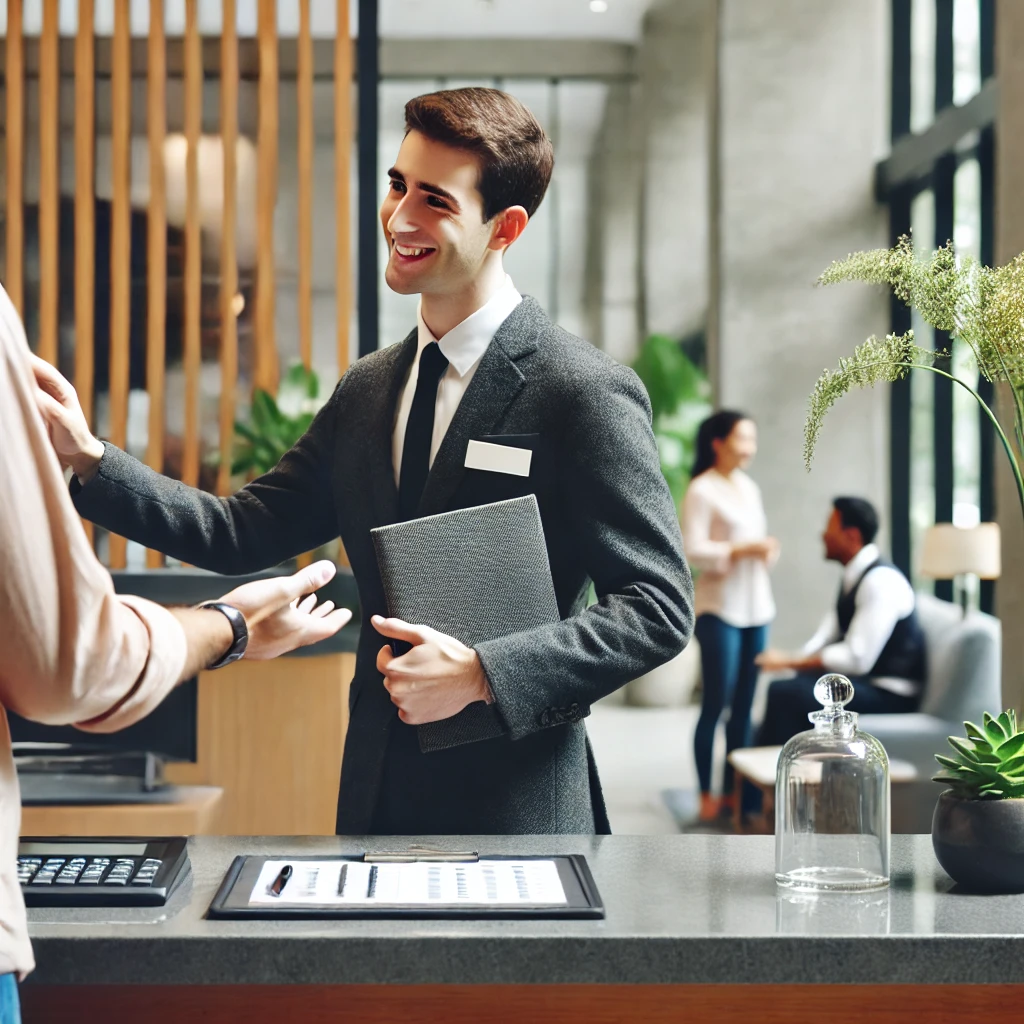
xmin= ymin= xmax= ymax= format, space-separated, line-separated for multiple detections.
xmin=253 ymin=0 xmax=278 ymax=392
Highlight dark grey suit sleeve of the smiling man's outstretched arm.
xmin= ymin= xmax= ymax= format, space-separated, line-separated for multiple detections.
xmin=71 ymin=384 xmax=342 ymax=575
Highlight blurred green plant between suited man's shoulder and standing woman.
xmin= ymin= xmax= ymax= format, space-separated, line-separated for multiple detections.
xmin=633 ymin=334 xmax=712 ymax=505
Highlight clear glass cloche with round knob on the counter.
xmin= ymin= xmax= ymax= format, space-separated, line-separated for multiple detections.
xmin=775 ymin=675 xmax=890 ymax=892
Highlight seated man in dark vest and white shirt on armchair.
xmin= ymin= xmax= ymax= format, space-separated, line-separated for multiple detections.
xmin=757 ymin=498 xmax=926 ymax=746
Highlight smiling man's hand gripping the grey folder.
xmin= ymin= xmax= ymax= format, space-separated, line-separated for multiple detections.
xmin=372 ymin=615 xmax=494 ymax=725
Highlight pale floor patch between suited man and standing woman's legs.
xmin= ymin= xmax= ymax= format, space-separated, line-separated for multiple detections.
xmin=587 ymin=702 xmax=699 ymax=836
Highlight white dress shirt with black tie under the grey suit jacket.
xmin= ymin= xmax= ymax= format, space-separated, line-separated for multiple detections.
xmin=391 ymin=274 xmax=522 ymax=484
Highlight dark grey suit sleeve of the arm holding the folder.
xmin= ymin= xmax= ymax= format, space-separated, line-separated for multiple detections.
xmin=476 ymin=365 xmax=693 ymax=739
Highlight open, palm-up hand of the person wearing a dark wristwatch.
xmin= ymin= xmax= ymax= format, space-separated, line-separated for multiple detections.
xmin=220 ymin=561 xmax=352 ymax=662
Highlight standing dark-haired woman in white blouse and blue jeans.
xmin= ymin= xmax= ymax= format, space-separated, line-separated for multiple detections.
xmin=682 ymin=410 xmax=778 ymax=821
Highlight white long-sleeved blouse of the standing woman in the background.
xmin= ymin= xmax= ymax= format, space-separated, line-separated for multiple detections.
xmin=682 ymin=469 xmax=775 ymax=629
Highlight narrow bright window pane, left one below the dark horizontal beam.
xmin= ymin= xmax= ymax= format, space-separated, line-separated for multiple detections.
xmin=910 ymin=188 xmax=935 ymax=590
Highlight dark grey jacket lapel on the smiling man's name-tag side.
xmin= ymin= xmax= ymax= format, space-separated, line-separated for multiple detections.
xmin=418 ymin=298 xmax=544 ymax=516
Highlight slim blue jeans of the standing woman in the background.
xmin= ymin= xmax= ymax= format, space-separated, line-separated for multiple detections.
xmin=693 ymin=614 xmax=768 ymax=793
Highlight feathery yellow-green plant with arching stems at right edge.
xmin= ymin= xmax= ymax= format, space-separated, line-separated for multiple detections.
xmin=804 ymin=236 xmax=1024 ymax=512
